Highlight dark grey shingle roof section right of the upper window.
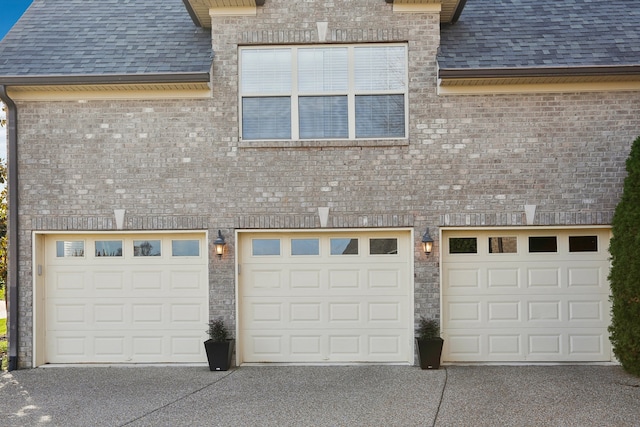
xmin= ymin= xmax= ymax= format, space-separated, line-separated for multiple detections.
xmin=438 ymin=0 xmax=640 ymax=69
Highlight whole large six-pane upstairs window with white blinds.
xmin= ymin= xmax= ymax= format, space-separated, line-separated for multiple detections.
xmin=240 ymin=44 xmax=407 ymax=140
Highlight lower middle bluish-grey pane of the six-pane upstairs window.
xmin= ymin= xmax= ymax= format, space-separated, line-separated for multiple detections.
xmin=298 ymin=96 xmax=349 ymax=139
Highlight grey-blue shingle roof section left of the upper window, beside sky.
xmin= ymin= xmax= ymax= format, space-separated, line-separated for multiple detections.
xmin=0 ymin=0 xmax=213 ymax=77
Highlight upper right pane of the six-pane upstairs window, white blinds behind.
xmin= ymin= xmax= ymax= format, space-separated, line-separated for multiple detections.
xmin=354 ymin=46 xmax=407 ymax=91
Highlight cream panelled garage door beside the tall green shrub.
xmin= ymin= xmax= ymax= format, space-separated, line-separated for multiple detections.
xmin=442 ymin=229 xmax=611 ymax=362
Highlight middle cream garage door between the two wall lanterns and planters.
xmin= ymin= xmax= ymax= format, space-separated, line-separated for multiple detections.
xmin=239 ymin=231 xmax=413 ymax=363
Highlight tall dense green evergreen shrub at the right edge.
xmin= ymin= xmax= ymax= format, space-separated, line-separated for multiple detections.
xmin=609 ymin=137 xmax=640 ymax=376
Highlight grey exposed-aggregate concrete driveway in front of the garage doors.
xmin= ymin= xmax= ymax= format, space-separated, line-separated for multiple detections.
xmin=0 ymin=365 xmax=640 ymax=426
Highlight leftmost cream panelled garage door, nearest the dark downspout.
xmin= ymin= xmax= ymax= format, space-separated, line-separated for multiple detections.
xmin=45 ymin=233 xmax=209 ymax=363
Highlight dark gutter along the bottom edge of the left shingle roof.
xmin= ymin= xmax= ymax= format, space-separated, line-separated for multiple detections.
xmin=0 ymin=72 xmax=210 ymax=86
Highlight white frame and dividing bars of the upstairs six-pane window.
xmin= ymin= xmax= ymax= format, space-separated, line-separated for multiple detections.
xmin=238 ymin=43 xmax=409 ymax=146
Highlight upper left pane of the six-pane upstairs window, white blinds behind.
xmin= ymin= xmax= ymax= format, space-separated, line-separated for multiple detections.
xmin=240 ymin=49 xmax=291 ymax=95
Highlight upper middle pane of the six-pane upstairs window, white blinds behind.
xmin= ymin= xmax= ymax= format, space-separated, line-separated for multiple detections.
xmin=298 ymin=48 xmax=349 ymax=93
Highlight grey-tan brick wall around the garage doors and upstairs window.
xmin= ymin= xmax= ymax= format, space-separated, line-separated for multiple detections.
xmin=11 ymin=0 xmax=640 ymax=367
